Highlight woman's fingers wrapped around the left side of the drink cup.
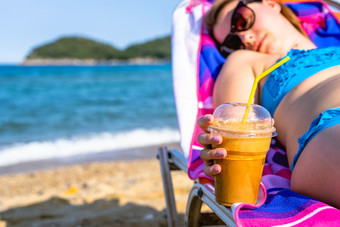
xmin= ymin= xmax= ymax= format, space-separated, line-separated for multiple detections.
xmin=197 ymin=114 xmax=227 ymax=176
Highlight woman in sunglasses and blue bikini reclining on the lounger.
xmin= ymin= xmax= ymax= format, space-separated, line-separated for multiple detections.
xmin=198 ymin=0 xmax=340 ymax=208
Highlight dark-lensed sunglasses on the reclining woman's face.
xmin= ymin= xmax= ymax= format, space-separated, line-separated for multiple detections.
xmin=219 ymin=1 xmax=255 ymax=57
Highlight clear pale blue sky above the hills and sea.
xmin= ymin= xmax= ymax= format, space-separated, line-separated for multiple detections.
xmin=0 ymin=0 xmax=181 ymax=63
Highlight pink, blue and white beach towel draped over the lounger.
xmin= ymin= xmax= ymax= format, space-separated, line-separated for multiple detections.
xmin=172 ymin=0 xmax=340 ymax=226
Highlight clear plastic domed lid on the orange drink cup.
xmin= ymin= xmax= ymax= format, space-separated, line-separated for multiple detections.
xmin=208 ymin=103 xmax=276 ymax=138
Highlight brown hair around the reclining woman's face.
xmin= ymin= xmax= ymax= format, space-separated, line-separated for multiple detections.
xmin=203 ymin=0 xmax=308 ymax=43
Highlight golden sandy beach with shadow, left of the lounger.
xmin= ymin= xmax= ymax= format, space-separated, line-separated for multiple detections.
xmin=0 ymin=144 xmax=193 ymax=227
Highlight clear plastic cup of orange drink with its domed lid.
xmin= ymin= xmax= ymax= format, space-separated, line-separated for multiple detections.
xmin=208 ymin=103 xmax=276 ymax=206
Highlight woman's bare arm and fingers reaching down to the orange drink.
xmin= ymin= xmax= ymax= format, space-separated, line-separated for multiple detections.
xmin=197 ymin=50 xmax=276 ymax=176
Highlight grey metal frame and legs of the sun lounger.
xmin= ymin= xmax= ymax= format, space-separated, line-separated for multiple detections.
xmin=157 ymin=147 xmax=236 ymax=227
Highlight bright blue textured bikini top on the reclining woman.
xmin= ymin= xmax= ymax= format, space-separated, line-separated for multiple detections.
xmin=261 ymin=47 xmax=340 ymax=116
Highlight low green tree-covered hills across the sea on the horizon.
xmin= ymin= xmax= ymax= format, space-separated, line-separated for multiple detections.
xmin=26 ymin=36 xmax=171 ymax=61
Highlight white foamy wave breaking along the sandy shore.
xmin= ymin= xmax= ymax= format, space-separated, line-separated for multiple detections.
xmin=0 ymin=128 xmax=179 ymax=166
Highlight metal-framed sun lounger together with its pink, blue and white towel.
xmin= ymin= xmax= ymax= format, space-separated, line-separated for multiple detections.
xmin=158 ymin=0 xmax=340 ymax=227
